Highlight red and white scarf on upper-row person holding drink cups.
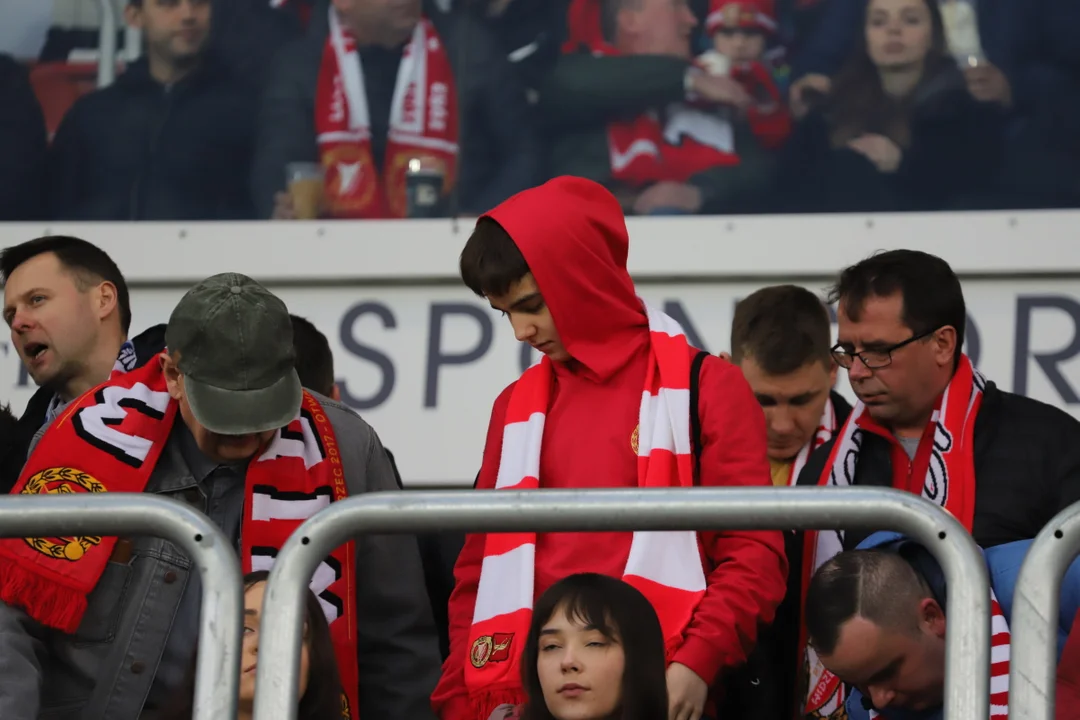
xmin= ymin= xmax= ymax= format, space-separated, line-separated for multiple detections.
xmin=315 ymin=6 xmax=458 ymax=219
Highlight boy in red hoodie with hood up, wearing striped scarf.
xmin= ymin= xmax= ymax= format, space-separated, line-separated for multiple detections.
xmin=432 ymin=177 xmax=787 ymax=720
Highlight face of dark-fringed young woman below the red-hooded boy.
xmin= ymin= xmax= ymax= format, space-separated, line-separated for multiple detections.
xmin=537 ymin=607 xmax=625 ymax=720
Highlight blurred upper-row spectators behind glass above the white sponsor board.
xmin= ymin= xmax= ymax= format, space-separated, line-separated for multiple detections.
xmin=0 ymin=0 xmax=1080 ymax=220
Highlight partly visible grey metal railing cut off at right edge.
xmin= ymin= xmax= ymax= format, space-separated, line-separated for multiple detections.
xmin=1009 ymin=503 xmax=1080 ymax=720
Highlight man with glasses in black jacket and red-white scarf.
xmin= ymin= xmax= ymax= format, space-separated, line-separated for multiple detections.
xmin=798 ymin=250 xmax=1080 ymax=549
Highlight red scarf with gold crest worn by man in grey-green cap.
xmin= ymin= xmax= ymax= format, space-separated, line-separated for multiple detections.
xmin=0 ymin=358 xmax=359 ymax=720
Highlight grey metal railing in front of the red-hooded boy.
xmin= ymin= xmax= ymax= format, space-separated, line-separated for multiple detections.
xmin=255 ymin=488 xmax=990 ymax=720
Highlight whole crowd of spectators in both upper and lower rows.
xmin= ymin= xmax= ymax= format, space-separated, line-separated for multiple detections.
xmin=0 ymin=0 xmax=1080 ymax=720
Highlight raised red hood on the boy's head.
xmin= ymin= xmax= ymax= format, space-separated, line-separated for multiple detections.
xmin=487 ymin=177 xmax=649 ymax=381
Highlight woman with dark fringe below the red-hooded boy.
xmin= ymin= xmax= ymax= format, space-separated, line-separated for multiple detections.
xmin=522 ymin=573 xmax=667 ymax=720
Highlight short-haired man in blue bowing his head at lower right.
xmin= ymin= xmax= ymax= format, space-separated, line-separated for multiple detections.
xmin=806 ymin=532 xmax=1080 ymax=720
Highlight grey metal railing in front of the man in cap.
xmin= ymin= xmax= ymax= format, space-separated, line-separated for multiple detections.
xmin=0 ymin=492 xmax=244 ymax=720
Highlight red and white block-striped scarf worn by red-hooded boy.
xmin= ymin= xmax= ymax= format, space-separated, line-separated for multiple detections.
xmin=465 ymin=304 xmax=705 ymax=720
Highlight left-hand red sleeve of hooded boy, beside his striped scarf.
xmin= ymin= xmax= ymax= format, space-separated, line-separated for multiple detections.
xmin=431 ymin=383 xmax=514 ymax=720
